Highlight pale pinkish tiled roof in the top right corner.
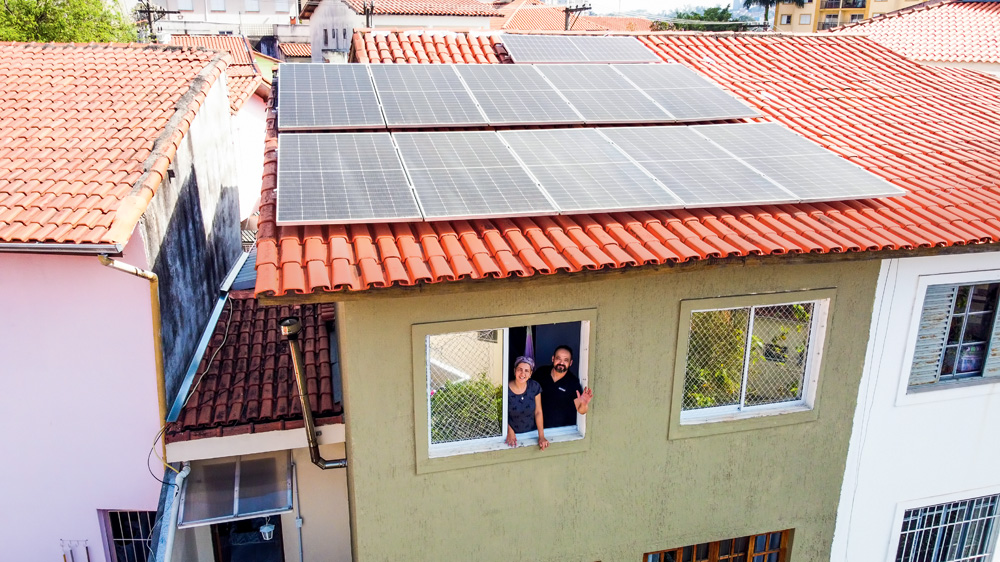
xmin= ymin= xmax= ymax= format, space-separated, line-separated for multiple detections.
xmin=834 ymin=0 xmax=1000 ymax=63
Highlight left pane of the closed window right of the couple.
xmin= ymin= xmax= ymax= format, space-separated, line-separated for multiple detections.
xmin=683 ymin=308 xmax=750 ymax=410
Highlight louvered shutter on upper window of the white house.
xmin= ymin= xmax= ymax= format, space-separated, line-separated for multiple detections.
xmin=910 ymin=285 xmax=956 ymax=386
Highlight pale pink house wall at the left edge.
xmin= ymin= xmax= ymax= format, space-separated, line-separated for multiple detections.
xmin=0 ymin=231 xmax=162 ymax=561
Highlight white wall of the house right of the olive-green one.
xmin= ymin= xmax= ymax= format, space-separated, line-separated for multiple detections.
xmin=831 ymin=253 xmax=1000 ymax=562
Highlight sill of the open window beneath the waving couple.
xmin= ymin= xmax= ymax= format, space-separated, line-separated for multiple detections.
xmin=417 ymin=426 xmax=590 ymax=474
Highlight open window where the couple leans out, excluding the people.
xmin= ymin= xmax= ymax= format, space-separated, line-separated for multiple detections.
xmin=414 ymin=313 xmax=591 ymax=466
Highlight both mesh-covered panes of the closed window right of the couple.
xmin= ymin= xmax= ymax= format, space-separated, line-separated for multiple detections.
xmin=682 ymin=302 xmax=816 ymax=410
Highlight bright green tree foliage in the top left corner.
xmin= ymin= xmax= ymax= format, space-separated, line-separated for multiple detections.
xmin=0 ymin=0 xmax=136 ymax=43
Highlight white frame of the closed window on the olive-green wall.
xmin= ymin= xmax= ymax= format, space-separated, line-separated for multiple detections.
xmin=675 ymin=293 xmax=830 ymax=425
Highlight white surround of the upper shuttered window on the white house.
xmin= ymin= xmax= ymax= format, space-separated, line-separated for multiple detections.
xmin=896 ymin=269 xmax=1000 ymax=406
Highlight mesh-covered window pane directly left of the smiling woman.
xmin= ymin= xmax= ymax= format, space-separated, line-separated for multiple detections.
xmin=427 ymin=330 xmax=505 ymax=445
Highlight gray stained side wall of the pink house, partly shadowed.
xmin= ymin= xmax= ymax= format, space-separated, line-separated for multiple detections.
xmin=141 ymin=75 xmax=242 ymax=408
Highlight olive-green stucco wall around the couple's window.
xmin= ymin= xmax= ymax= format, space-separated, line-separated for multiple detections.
xmin=332 ymin=261 xmax=878 ymax=562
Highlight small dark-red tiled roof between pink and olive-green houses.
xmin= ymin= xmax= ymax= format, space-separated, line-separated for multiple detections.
xmin=166 ymin=291 xmax=343 ymax=443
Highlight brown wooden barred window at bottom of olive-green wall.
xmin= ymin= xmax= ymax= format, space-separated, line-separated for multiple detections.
xmin=642 ymin=530 xmax=792 ymax=562
